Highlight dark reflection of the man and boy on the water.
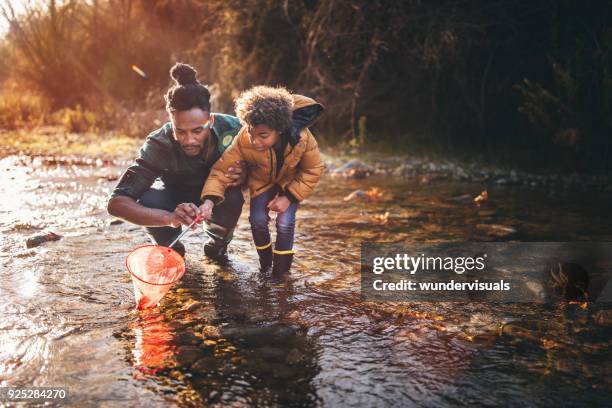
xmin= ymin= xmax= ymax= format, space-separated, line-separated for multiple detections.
xmin=115 ymin=262 xmax=318 ymax=406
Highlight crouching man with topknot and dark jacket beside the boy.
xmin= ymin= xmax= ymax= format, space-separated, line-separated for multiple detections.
xmin=108 ymin=63 xmax=246 ymax=262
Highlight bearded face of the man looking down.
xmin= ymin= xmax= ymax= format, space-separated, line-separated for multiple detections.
xmin=170 ymin=108 xmax=213 ymax=157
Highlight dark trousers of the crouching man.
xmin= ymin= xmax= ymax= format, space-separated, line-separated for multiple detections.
xmin=138 ymin=187 xmax=244 ymax=248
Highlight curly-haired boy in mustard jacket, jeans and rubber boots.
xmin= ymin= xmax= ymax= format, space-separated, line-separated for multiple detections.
xmin=199 ymin=86 xmax=325 ymax=276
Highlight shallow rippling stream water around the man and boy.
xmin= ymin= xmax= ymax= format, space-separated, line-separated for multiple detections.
xmin=0 ymin=157 xmax=612 ymax=407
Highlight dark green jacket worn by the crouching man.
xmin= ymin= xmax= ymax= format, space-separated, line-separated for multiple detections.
xmin=111 ymin=113 xmax=240 ymax=200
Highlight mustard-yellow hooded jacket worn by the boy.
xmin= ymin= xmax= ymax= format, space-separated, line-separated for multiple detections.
xmin=200 ymin=95 xmax=325 ymax=204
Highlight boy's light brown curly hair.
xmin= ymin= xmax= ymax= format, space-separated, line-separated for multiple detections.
xmin=235 ymin=86 xmax=293 ymax=133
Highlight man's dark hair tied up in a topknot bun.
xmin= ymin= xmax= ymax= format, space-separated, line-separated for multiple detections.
xmin=165 ymin=62 xmax=210 ymax=112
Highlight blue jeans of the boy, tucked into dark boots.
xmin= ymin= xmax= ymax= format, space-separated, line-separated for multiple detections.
xmin=249 ymin=187 xmax=298 ymax=251
